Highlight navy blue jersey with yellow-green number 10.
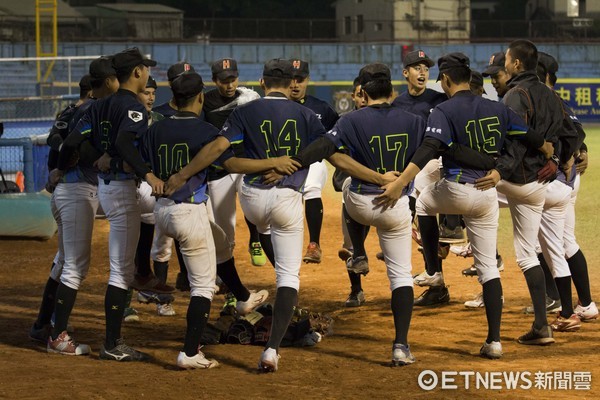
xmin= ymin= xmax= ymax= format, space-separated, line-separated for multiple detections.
xmin=142 ymin=112 xmax=219 ymax=204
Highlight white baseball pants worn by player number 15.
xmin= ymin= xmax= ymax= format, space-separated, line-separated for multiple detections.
xmin=418 ymin=179 xmax=500 ymax=285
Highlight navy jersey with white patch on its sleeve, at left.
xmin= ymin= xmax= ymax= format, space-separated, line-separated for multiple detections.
xmin=72 ymin=89 xmax=148 ymax=180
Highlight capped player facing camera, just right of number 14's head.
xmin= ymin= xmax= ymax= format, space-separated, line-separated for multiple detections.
xmin=291 ymin=58 xmax=340 ymax=264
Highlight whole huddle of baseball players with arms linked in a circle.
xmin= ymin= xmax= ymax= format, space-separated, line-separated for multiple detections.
xmin=29 ymin=40 xmax=598 ymax=372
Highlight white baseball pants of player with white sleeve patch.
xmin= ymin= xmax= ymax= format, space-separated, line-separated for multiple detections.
xmin=98 ymin=179 xmax=140 ymax=290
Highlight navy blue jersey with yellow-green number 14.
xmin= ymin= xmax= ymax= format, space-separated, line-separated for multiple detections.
xmin=221 ymin=93 xmax=325 ymax=191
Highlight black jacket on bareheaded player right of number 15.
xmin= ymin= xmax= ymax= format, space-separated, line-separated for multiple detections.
xmin=502 ymin=71 xmax=581 ymax=184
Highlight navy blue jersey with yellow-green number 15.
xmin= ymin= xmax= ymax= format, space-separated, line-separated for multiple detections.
xmin=425 ymin=91 xmax=527 ymax=183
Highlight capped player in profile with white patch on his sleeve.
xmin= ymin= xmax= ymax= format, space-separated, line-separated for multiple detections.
xmin=59 ymin=48 xmax=164 ymax=361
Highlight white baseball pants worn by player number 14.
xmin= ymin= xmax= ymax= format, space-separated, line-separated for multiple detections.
xmin=240 ymin=183 xmax=304 ymax=290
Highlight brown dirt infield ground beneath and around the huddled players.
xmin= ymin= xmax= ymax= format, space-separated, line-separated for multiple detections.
xmin=0 ymin=184 xmax=600 ymax=399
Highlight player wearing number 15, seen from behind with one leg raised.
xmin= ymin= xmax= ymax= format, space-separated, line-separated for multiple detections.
xmin=378 ymin=53 xmax=552 ymax=359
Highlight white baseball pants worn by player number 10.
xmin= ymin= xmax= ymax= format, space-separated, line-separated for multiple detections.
xmin=154 ymin=198 xmax=217 ymax=300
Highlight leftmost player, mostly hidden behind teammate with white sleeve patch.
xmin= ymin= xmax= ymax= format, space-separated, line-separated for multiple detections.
xmin=30 ymin=57 xmax=119 ymax=355
